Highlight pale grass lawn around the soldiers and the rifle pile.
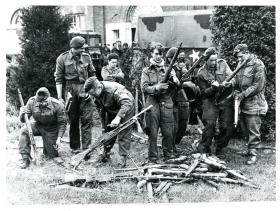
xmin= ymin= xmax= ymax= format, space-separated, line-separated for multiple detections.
xmin=6 ymin=112 xmax=276 ymax=205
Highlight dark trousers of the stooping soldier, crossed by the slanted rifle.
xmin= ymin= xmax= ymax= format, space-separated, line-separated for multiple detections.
xmin=104 ymin=106 xmax=135 ymax=156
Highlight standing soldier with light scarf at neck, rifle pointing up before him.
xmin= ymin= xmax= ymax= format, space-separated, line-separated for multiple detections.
xmin=141 ymin=45 xmax=179 ymax=163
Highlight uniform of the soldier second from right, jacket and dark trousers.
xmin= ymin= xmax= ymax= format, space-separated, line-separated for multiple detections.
xmin=197 ymin=59 xmax=234 ymax=152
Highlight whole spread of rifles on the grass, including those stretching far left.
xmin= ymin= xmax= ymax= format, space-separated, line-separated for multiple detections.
xmin=51 ymin=153 xmax=259 ymax=202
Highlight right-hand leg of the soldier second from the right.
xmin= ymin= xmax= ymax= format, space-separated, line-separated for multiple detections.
xmin=215 ymin=106 xmax=234 ymax=151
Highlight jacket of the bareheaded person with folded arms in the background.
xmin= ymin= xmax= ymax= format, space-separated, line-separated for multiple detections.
xmin=101 ymin=65 xmax=124 ymax=83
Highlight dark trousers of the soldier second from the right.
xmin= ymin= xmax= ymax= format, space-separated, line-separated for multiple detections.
xmin=198 ymin=105 xmax=234 ymax=153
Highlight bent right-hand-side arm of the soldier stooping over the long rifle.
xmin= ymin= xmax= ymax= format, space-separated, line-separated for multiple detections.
xmin=113 ymin=90 xmax=134 ymax=119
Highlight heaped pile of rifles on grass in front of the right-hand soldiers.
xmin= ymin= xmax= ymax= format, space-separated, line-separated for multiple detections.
xmin=114 ymin=153 xmax=259 ymax=202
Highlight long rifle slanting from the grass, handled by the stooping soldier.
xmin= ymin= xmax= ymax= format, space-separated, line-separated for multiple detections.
xmin=71 ymin=105 xmax=153 ymax=169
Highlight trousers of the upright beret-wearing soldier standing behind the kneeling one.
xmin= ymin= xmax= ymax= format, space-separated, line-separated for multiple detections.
xmin=65 ymin=83 xmax=93 ymax=149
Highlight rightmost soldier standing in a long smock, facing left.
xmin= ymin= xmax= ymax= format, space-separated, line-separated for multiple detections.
xmin=232 ymin=44 xmax=268 ymax=165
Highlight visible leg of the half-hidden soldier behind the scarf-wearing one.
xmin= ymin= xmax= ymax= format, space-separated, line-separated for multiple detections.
xmin=175 ymin=102 xmax=189 ymax=144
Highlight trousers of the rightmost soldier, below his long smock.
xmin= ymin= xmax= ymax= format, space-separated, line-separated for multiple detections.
xmin=240 ymin=112 xmax=261 ymax=155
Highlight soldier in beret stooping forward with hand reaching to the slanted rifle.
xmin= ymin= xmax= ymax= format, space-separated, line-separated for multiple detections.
xmin=85 ymin=77 xmax=135 ymax=167
